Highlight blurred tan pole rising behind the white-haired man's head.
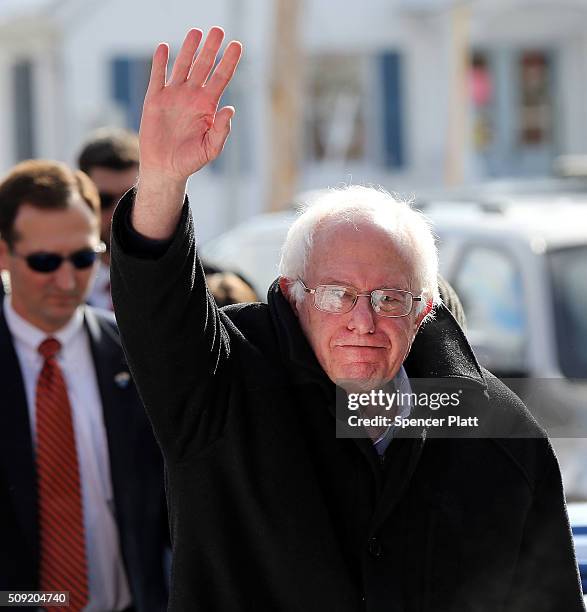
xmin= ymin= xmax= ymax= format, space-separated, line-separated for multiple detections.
xmin=268 ymin=0 xmax=303 ymax=211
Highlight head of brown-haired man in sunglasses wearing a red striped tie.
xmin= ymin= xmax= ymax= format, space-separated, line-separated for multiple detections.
xmin=0 ymin=160 xmax=104 ymax=332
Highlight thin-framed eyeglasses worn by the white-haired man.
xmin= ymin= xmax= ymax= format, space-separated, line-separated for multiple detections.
xmin=298 ymin=278 xmax=424 ymax=317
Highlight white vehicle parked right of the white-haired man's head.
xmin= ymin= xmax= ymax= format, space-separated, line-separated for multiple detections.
xmin=425 ymin=194 xmax=587 ymax=500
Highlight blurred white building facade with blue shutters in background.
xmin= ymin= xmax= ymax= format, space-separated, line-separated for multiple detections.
xmin=0 ymin=0 xmax=587 ymax=240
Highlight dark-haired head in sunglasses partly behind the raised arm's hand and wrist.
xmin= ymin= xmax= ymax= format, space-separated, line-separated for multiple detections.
xmin=78 ymin=128 xmax=139 ymax=263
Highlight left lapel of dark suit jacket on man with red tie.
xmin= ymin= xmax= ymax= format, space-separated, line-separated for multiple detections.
xmin=0 ymin=308 xmax=38 ymax=558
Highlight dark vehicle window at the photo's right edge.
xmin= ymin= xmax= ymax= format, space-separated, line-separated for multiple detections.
xmin=548 ymin=245 xmax=587 ymax=378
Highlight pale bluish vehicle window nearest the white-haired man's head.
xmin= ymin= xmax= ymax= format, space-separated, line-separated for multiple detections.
xmin=453 ymin=246 xmax=527 ymax=375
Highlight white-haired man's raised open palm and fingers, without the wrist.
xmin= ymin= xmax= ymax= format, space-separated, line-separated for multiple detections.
xmin=140 ymin=27 xmax=242 ymax=183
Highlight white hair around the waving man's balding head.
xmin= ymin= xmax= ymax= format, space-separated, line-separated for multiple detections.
xmin=279 ymin=185 xmax=440 ymax=312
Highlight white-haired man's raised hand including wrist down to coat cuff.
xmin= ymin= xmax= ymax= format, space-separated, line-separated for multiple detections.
xmin=131 ymin=28 xmax=242 ymax=239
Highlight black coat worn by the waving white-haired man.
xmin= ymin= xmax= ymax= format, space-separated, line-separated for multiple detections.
xmin=112 ymin=194 xmax=584 ymax=612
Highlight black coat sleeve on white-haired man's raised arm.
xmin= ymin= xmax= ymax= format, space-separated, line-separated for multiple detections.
xmin=111 ymin=192 xmax=230 ymax=461
